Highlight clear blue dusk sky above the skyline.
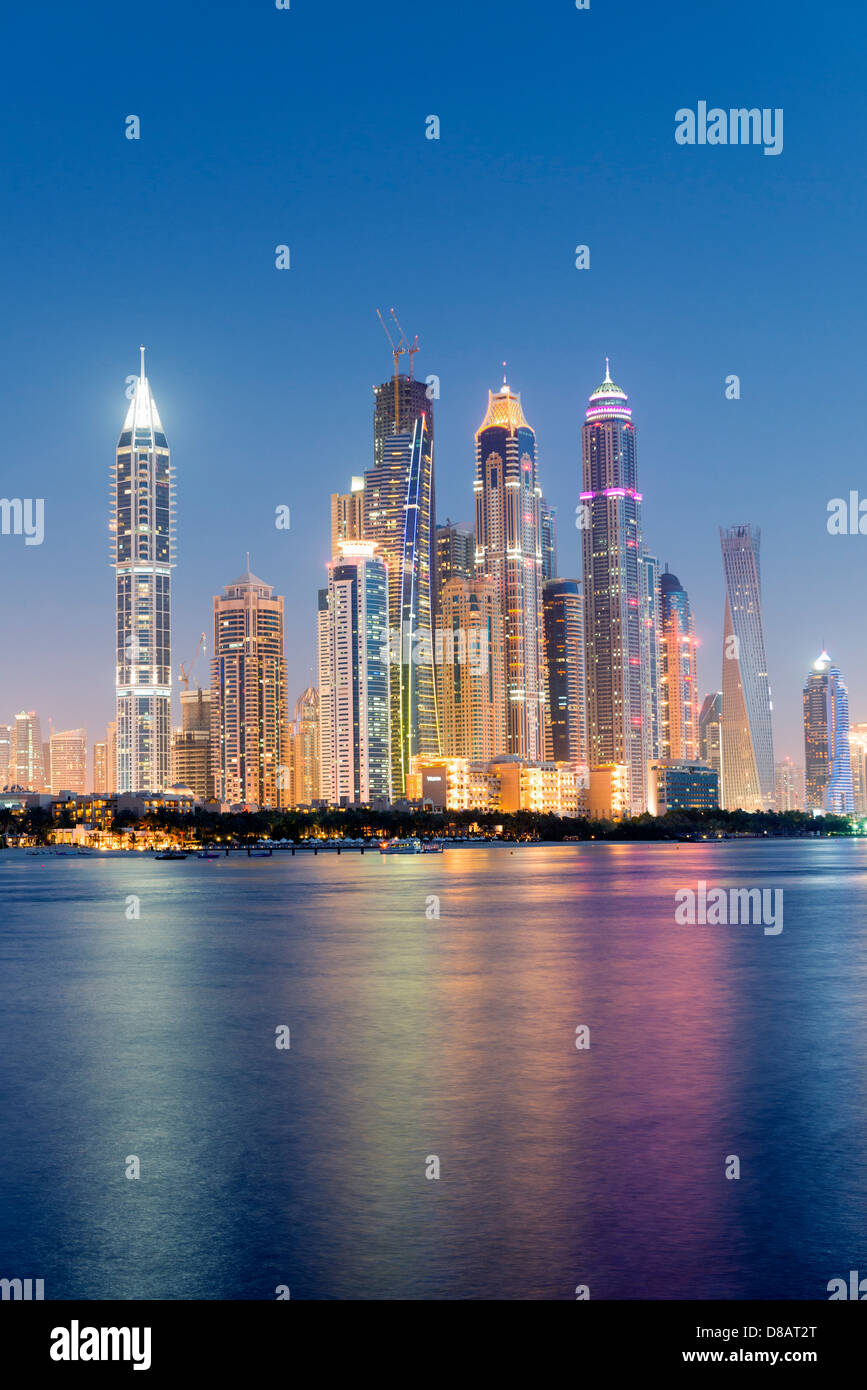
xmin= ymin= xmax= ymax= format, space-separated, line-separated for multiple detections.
xmin=0 ymin=0 xmax=867 ymax=760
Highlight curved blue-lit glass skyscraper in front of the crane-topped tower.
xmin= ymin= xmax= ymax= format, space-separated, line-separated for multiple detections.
xmin=363 ymin=405 xmax=439 ymax=799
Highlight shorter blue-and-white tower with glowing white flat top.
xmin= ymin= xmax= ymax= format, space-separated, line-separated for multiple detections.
xmin=320 ymin=541 xmax=391 ymax=805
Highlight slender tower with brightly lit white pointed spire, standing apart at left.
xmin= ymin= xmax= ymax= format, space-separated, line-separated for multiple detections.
xmin=111 ymin=348 xmax=175 ymax=792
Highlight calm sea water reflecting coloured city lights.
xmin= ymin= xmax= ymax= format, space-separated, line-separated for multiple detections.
xmin=0 ymin=841 xmax=867 ymax=1298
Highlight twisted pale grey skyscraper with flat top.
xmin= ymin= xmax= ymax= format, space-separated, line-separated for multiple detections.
xmin=720 ymin=525 xmax=774 ymax=810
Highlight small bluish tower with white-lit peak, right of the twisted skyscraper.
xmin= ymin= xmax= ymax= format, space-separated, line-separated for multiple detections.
xmin=803 ymin=652 xmax=854 ymax=816
